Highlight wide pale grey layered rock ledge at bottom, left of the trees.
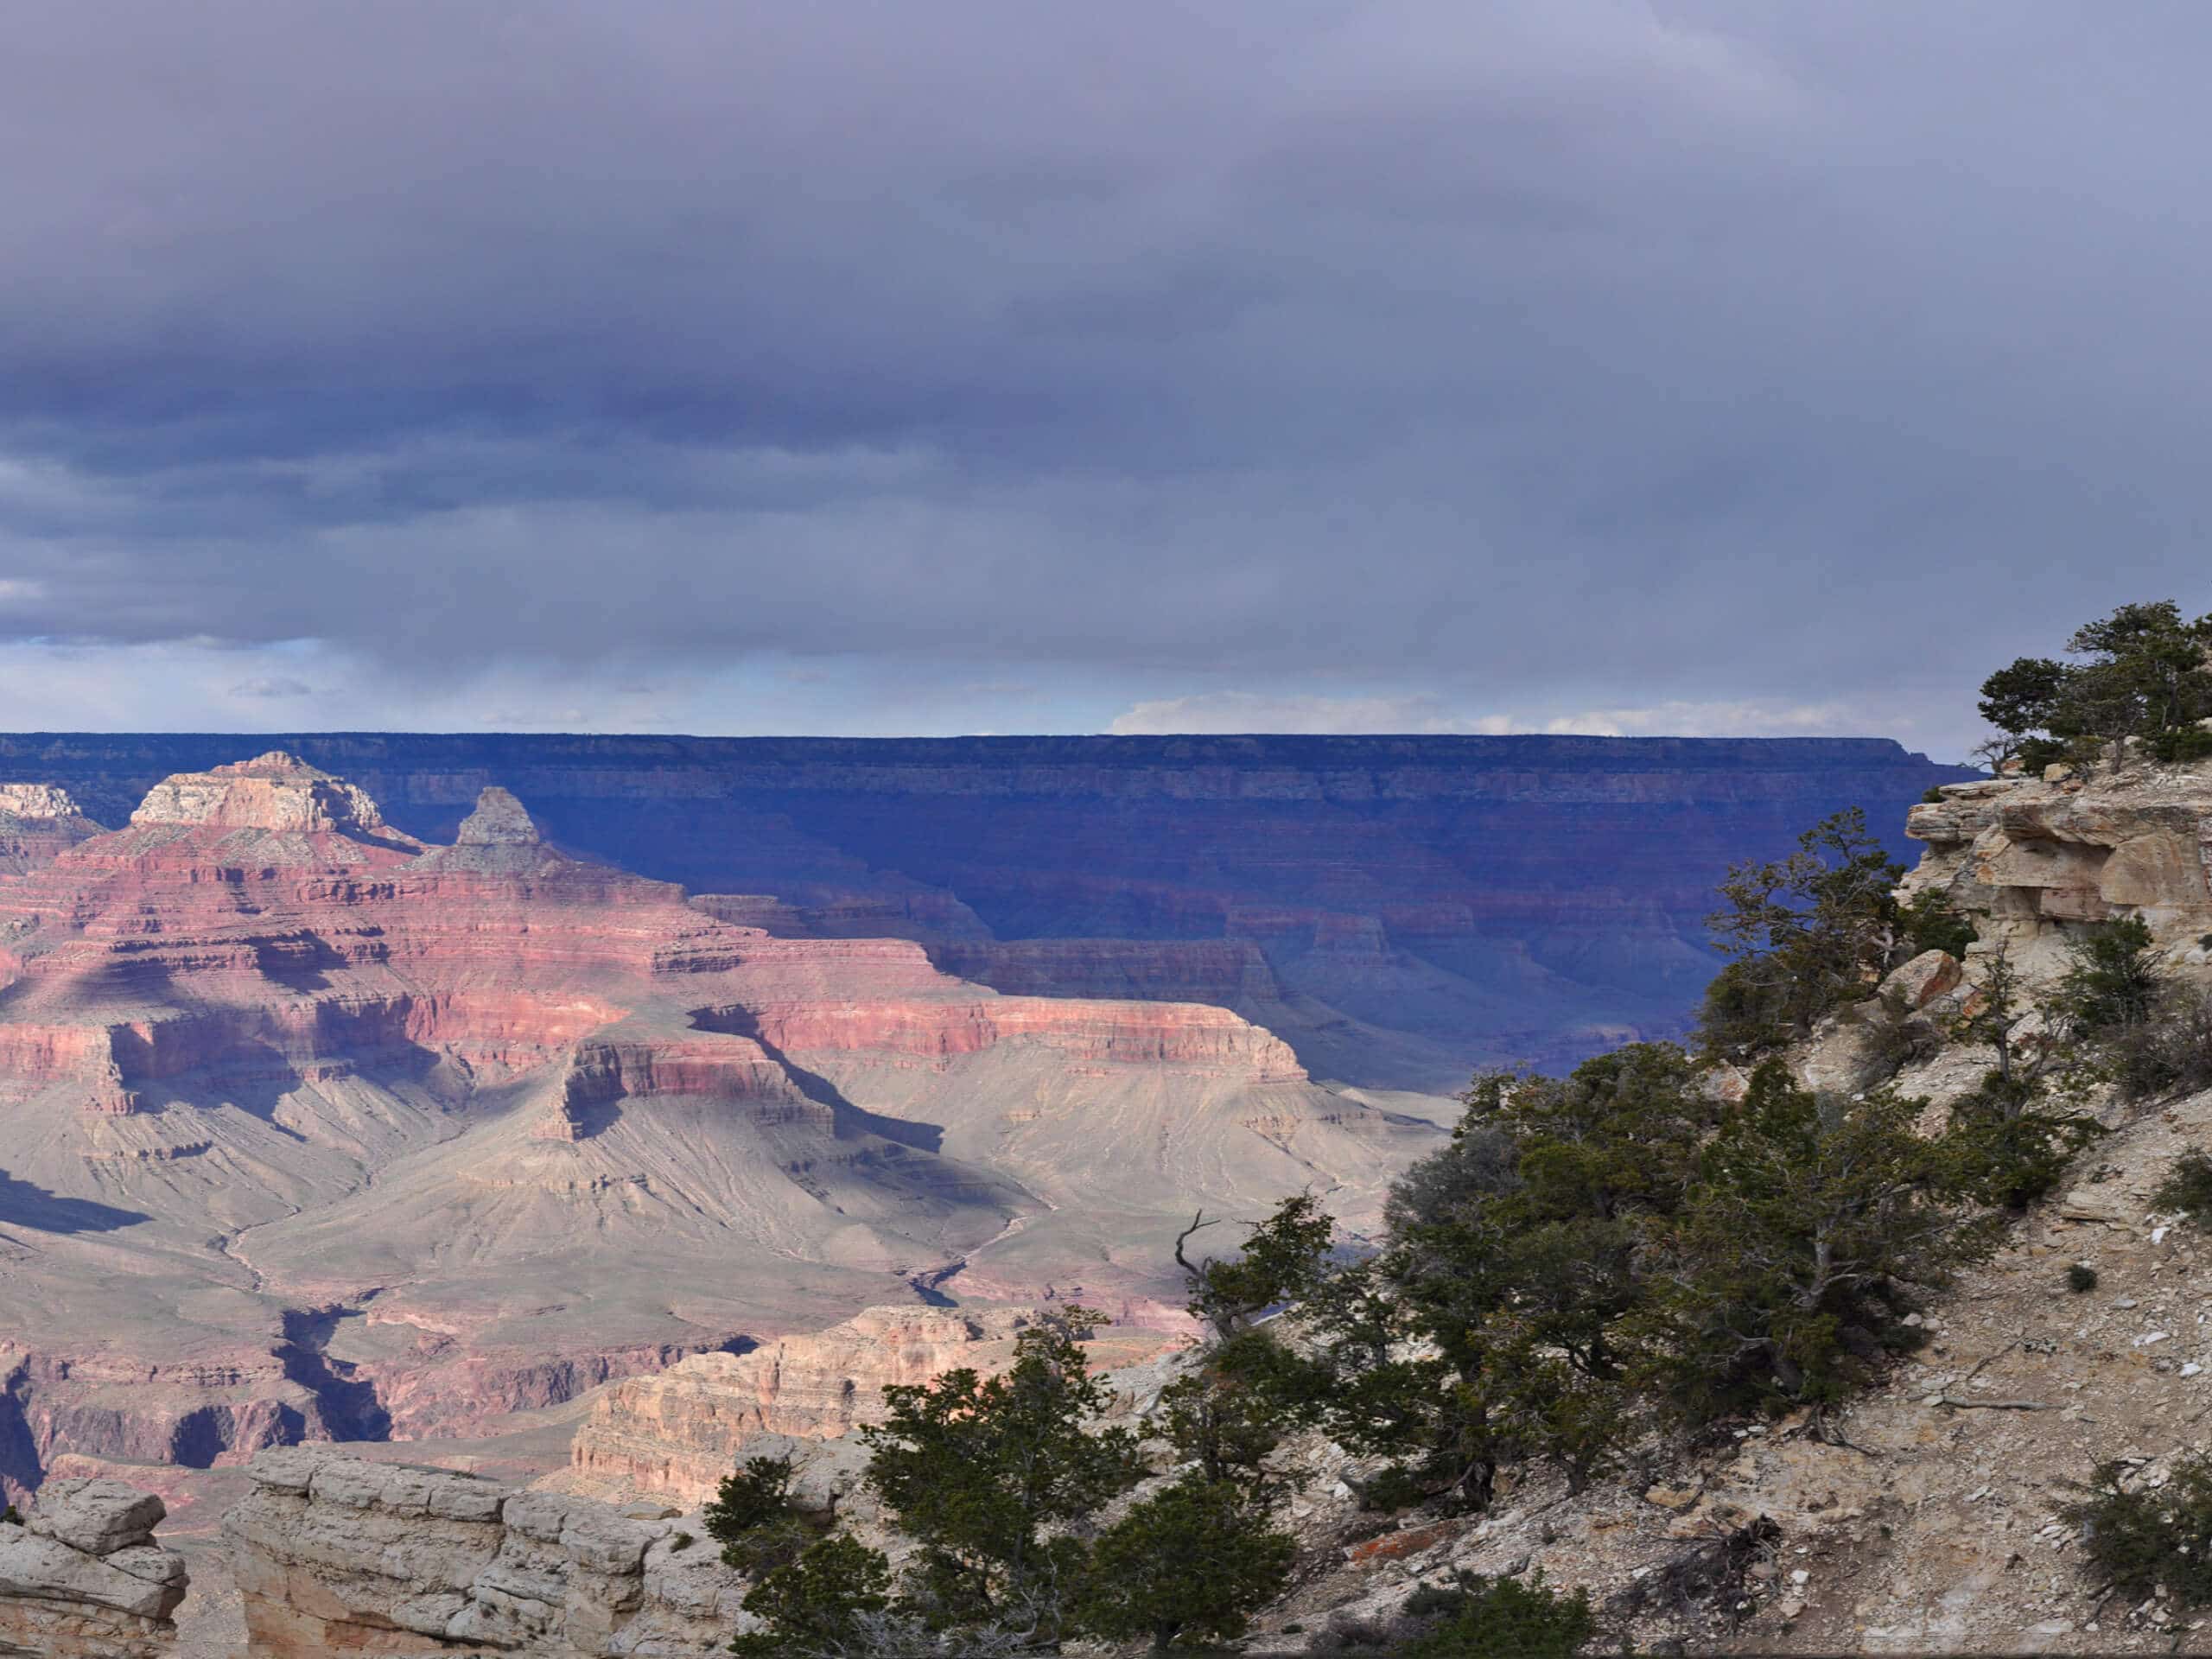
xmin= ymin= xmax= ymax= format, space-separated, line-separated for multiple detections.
xmin=224 ymin=1446 xmax=750 ymax=1659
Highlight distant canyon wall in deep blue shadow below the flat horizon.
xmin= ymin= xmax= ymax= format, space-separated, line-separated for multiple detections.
xmin=0 ymin=734 xmax=1967 ymax=1090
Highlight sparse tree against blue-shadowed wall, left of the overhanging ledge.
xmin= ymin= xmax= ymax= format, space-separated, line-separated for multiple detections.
xmin=1699 ymin=807 xmax=1933 ymax=1062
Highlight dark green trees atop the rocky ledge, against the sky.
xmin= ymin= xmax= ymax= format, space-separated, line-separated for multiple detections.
xmin=1980 ymin=600 xmax=2212 ymax=766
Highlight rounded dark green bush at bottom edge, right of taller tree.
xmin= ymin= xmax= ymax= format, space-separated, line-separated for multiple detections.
xmin=1079 ymin=1476 xmax=1296 ymax=1648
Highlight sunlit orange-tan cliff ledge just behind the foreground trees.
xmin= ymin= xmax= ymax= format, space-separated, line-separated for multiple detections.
xmin=564 ymin=1307 xmax=1181 ymax=1504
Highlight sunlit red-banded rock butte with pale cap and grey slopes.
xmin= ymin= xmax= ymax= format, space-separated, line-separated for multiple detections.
xmin=0 ymin=752 xmax=1435 ymax=1493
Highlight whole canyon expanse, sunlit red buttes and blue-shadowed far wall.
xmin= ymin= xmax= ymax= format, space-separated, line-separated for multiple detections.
xmin=0 ymin=736 xmax=1974 ymax=1652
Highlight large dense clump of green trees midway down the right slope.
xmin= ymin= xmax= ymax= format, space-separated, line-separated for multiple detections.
xmin=1285 ymin=1044 xmax=2008 ymax=1509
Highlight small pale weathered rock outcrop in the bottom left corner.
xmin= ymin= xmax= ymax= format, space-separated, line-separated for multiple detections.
xmin=0 ymin=1480 xmax=190 ymax=1659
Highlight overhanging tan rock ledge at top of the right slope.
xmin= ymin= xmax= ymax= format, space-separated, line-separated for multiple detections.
xmin=1907 ymin=761 xmax=2212 ymax=984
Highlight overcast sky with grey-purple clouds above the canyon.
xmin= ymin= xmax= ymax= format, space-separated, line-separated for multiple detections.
xmin=0 ymin=0 xmax=2212 ymax=759
